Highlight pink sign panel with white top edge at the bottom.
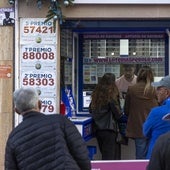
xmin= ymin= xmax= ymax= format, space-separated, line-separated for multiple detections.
xmin=92 ymin=160 xmax=148 ymax=170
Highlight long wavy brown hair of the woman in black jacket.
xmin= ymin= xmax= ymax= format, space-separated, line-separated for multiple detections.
xmin=91 ymin=73 xmax=119 ymax=108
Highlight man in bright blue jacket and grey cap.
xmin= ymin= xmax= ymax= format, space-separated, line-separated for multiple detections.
xmin=143 ymin=76 xmax=170 ymax=159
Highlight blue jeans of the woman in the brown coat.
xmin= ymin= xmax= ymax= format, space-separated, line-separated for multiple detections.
xmin=134 ymin=138 xmax=148 ymax=159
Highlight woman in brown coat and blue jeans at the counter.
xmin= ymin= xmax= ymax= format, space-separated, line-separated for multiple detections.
xmin=124 ymin=66 xmax=158 ymax=159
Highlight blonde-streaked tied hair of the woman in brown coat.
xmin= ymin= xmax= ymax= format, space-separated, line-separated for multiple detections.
xmin=137 ymin=66 xmax=154 ymax=94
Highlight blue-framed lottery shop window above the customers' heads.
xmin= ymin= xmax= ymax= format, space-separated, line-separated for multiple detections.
xmin=79 ymin=33 xmax=166 ymax=111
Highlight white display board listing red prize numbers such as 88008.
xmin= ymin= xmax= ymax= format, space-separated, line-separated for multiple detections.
xmin=20 ymin=18 xmax=57 ymax=114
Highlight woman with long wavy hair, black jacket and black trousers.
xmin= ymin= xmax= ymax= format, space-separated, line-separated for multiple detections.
xmin=89 ymin=73 xmax=122 ymax=160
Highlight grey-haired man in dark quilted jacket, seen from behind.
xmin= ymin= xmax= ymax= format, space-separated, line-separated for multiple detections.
xmin=5 ymin=88 xmax=91 ymax=170
